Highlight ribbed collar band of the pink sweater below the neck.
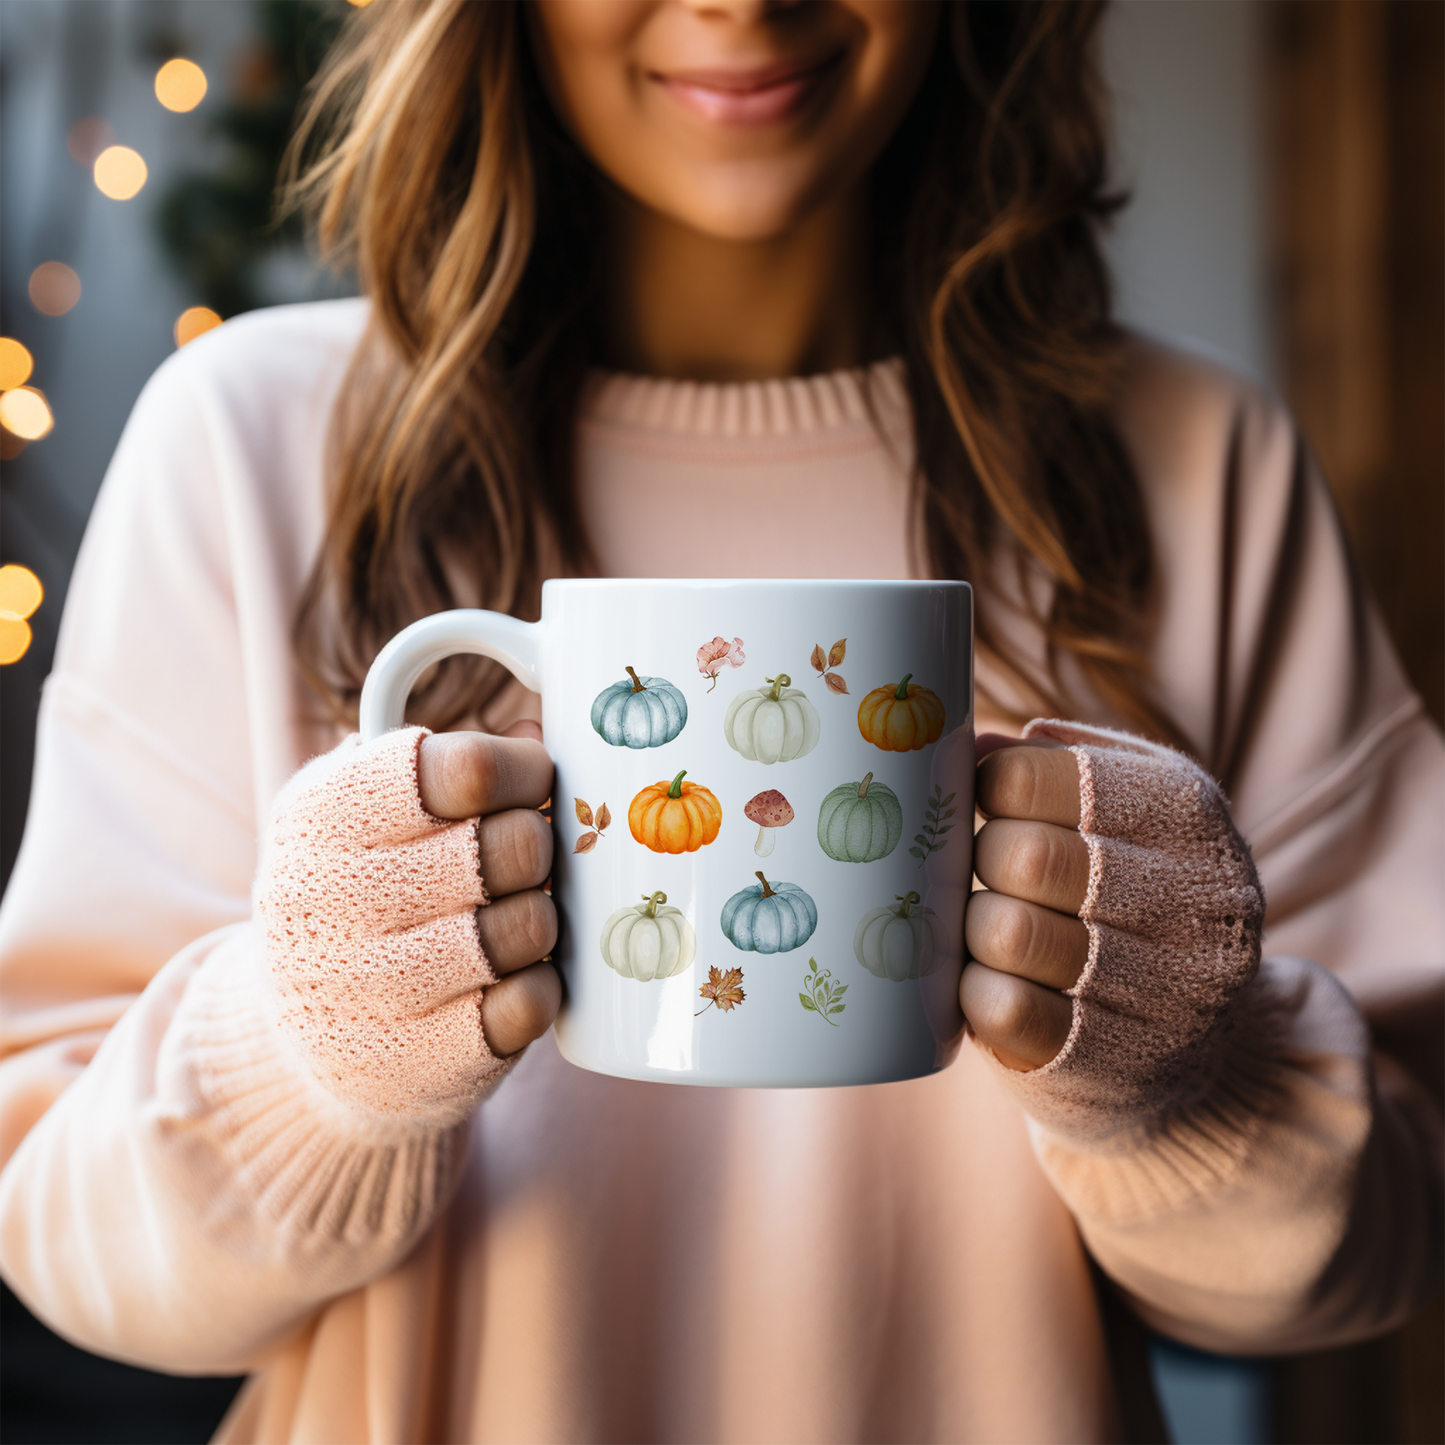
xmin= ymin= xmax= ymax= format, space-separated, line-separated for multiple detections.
xmin=582 ymin=357 xmax=907 ymax=438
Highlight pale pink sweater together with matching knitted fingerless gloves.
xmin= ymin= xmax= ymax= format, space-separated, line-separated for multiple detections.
xmin=0 ymin=303 xmax=1445 ymax=1442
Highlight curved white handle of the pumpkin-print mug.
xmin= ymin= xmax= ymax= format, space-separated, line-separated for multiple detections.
xmin=361 ymin=607 xmax=542 ymax=743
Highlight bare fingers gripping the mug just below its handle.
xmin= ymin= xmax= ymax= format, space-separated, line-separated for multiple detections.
xmin=416 ymin=721 xmax=562 ymax=1059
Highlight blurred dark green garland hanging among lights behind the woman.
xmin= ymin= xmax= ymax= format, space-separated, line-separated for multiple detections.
xmin=156 ymin=0 xmax=345 ymax=316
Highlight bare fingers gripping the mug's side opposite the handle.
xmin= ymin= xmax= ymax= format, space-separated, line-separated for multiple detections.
xmin=958 ymin=734 xmax=1090 ymax=1069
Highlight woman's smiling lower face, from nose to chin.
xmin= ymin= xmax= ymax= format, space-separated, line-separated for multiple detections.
xmin=527 ymin=0 xmax=939 ymax=240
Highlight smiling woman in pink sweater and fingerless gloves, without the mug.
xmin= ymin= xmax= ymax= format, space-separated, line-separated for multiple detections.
xmin=0 ymin=0 xmax=1442 ymax=1441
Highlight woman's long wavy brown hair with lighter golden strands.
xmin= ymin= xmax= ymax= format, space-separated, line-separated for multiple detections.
xmin=286 ymin=0 xmax=1176 ymax=737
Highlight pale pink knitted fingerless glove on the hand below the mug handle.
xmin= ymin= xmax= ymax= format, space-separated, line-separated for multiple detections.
xmin=256 ymin=728 xmax=506 ymax=1124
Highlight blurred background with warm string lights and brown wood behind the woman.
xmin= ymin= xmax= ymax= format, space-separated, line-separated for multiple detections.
xmin=0 ymin=0 xmax=1445 ymax=1445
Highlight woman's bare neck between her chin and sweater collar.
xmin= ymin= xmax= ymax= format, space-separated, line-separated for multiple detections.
xmin=604 ymin=194 xmax=867 ymax=381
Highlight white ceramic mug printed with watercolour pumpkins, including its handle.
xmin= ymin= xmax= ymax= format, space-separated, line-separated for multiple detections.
xmin=361 ymin=578 xmax=974 ymax=1088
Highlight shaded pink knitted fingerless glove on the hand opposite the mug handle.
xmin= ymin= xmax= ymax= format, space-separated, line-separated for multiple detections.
xmin=1003 ymin=720 xmax=1264 ymax=1143
